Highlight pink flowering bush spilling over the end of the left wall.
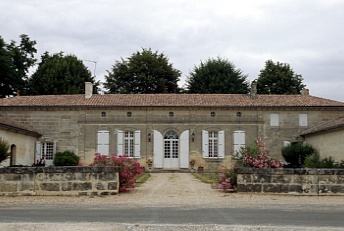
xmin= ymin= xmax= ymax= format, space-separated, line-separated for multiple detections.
xmin=90 ymin=153 xmax=142 ymax=192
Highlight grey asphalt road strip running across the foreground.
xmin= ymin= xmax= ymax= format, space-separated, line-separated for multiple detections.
xmin=0 ymin=207 xmax=344 ymax=226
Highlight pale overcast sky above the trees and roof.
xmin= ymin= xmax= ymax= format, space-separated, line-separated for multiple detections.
xmin=0 ymin=0 xmax=344 ymax=102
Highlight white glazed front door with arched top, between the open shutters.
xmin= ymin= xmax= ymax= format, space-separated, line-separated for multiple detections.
xmin=164 ymin=131 xmax=179 ymax=168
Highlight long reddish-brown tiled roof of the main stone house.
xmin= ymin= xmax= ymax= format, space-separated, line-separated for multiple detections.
xmin=0 ymin=94 xmax=344 ymax=107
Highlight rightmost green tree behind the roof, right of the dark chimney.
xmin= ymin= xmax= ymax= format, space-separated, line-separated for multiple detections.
xmin=257 ymin=60 xmax=306 ymax=95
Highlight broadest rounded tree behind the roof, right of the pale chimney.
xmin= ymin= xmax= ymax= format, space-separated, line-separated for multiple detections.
xmin=104 ymin=49 xmax=181 ymax=94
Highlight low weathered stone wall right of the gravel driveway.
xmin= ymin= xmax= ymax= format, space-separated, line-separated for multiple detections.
xmin=237 ymin=168 xmax=344 ymax=195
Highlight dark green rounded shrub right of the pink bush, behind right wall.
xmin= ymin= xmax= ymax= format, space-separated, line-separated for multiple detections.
xmin=282 ymin=143 xmax=315 ymax=168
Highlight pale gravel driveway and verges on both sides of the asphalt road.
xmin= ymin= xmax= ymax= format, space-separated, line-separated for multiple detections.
xmin=0 ymin=173 xmax=344 ymax=231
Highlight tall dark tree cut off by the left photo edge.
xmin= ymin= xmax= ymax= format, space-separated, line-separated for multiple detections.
xmin=0 ymin=34 xmax=37 ymax=98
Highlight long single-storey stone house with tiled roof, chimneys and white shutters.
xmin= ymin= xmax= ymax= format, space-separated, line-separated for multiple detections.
xmin=0 ymin=83 xmax=344 ymax=169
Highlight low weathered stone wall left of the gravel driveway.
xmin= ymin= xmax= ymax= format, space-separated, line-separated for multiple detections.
xmin=0 ymin=167 xmax=119 ymax=196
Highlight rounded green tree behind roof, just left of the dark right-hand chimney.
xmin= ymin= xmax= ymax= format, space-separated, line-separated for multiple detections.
xmin=186 ymin=57 xmax=249 ymax=94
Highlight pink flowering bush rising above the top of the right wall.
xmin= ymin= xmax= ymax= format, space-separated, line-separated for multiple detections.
xmin=238 ymin=138 xmax=284 ymax=168
